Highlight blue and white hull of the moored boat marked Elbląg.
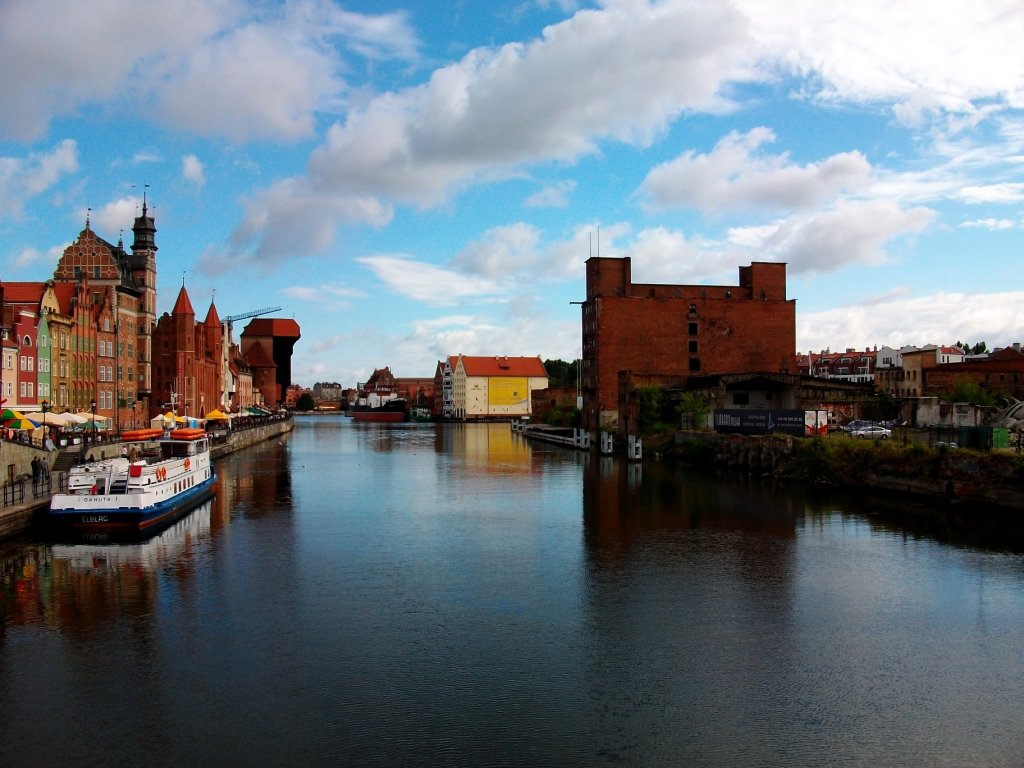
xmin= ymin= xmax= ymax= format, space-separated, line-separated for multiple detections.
xmin=48 ymin=473 xmax=217 ymax=534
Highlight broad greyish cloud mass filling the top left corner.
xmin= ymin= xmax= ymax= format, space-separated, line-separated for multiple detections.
xmin=0 ymin=0 xmax=418 ymax=140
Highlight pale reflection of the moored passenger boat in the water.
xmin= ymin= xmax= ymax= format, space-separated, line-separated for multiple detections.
xmin=51 ymin=500 xmax=213 ymax=571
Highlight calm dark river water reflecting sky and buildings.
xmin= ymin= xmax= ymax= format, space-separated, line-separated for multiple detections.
xmin=0 ymin=417 xmax=1024 ymax=767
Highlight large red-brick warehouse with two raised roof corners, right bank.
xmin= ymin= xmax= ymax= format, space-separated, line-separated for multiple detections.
xmin=583 ymin=257 xmax=797 ymax=431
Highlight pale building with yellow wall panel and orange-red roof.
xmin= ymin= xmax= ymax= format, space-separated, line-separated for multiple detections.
xmin=453 ymin=354 xmax=548 ymax=420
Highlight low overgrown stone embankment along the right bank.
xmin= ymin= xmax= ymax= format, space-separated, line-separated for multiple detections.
xmin=672 ymin=432 xmax=1024 ymax=511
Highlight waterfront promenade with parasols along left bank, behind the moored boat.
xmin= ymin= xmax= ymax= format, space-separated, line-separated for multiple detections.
xmin=0 ymin=415 xmax=294 ymax=541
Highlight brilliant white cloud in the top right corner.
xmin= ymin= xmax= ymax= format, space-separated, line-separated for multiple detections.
xmin=737 ymin=0 xmax=1024 ymax=122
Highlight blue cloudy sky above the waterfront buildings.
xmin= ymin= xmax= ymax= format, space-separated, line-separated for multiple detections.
xmin=0 ymin=0 xmax=1024 ymax=386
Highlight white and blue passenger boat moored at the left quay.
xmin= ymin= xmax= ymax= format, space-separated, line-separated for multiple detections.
xmin=49 ymin=429 xmax=217 ymax=532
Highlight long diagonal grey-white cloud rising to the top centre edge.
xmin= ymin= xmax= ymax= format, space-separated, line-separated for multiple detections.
xmin=224 ymin=0 xmax=748 ymax=268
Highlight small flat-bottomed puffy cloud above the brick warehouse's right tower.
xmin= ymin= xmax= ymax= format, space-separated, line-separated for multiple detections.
xmin=643 ymin=127 xmax=871 ymax=213
